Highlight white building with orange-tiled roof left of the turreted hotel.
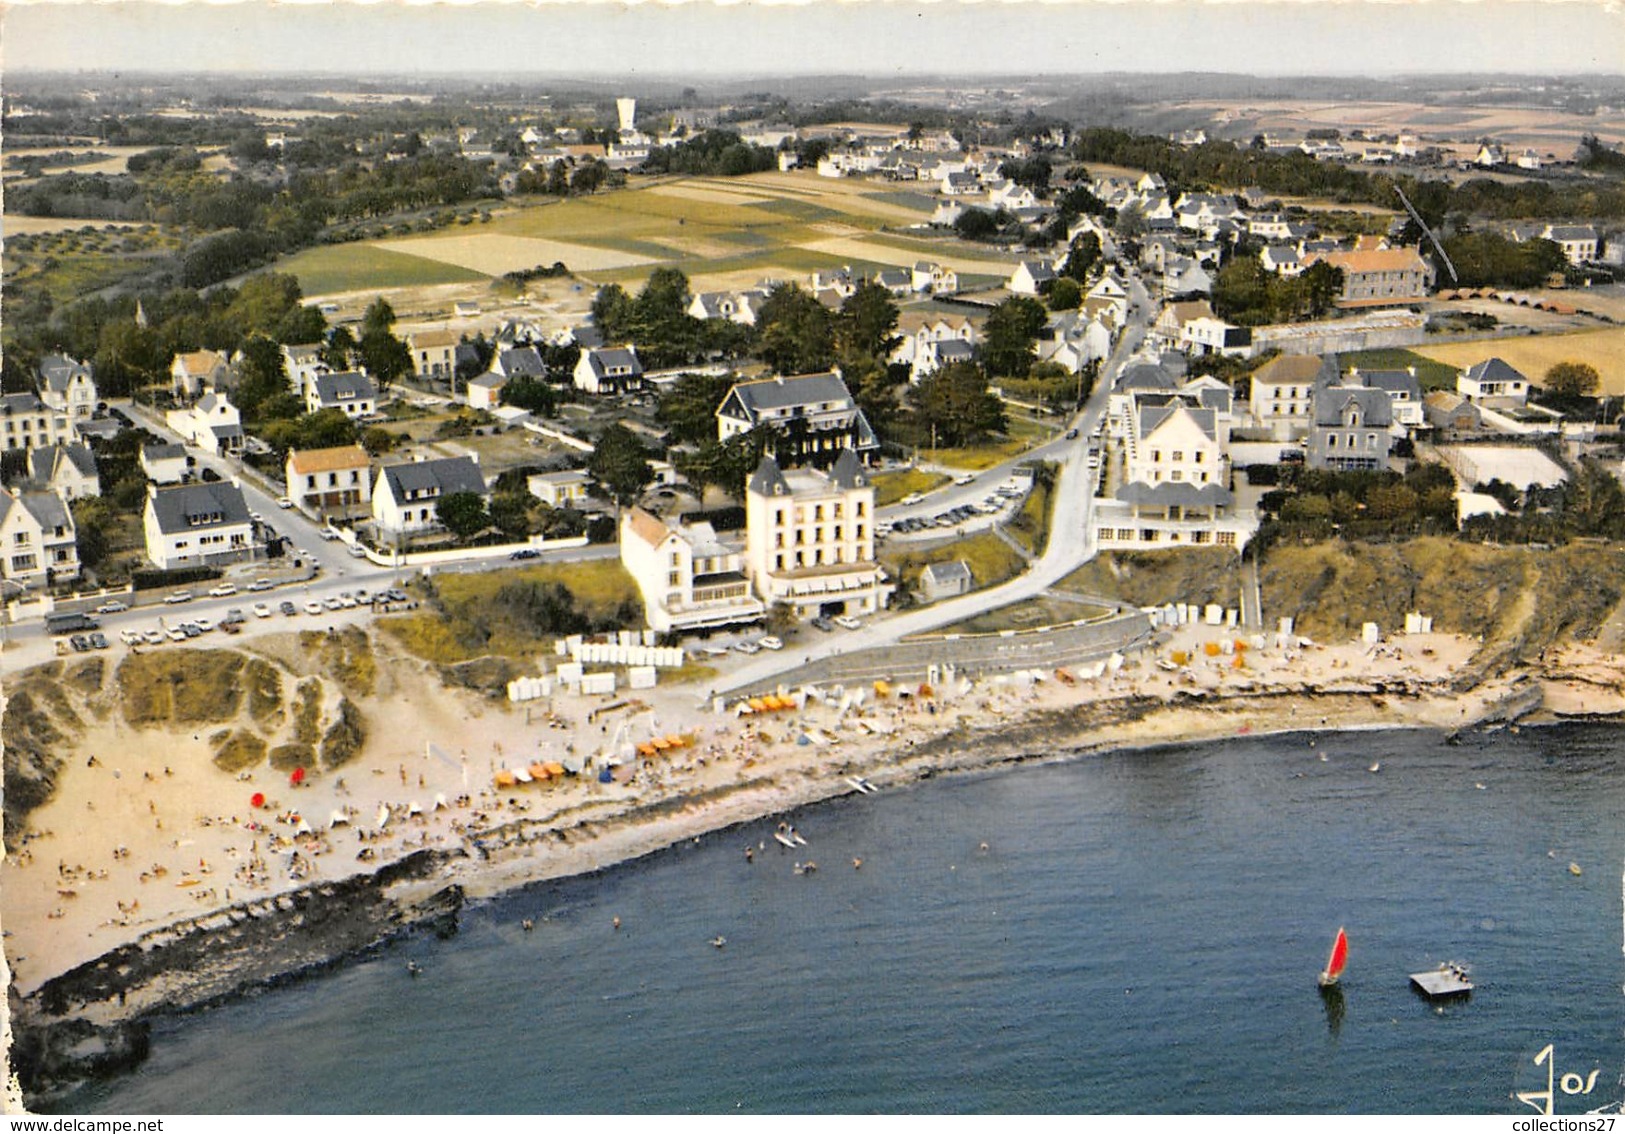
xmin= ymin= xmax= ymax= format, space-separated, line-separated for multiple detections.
xmin=621 ymin=507 xmax=767 ymax=632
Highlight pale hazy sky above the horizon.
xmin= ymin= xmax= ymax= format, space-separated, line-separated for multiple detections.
xmin=0 ymin=0 xmax=1625 ymax=80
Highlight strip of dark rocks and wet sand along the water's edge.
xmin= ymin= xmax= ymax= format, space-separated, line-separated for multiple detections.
xmin=10 ymin=659 xmax=1573 ymax=1102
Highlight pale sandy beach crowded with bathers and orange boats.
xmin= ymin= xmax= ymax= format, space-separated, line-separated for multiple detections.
xmin=0 ymin=627 xmax=1625 ymax=1098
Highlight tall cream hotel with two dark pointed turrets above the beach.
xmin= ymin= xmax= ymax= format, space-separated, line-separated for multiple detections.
xmin=744 ymin=450 xmax=897 ymax=619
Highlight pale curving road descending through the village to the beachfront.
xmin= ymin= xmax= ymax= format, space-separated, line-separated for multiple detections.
xmin=715 ymin=278 xmax=1155 ymax=692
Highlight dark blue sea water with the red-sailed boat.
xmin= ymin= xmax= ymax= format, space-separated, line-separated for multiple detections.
xmin=57 ymin=726 xmax=1625 ymax=1115
